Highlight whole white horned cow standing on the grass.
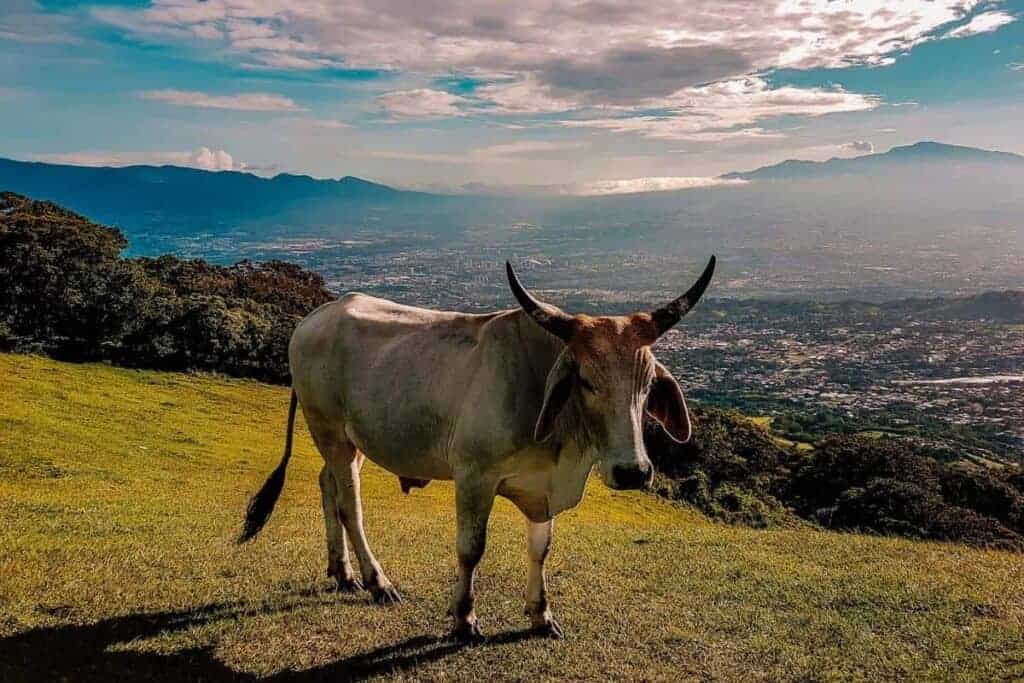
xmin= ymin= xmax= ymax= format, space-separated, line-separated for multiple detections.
xmin=240 ymin=256 xmax=715 ymax=640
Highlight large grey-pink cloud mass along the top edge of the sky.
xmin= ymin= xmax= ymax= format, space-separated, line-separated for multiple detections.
xmin=94 ymin=0 xmax=999 ymax=77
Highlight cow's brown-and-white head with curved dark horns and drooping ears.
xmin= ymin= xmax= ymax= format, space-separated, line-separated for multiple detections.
xmin=506 ymin=256 xmax=715 ymax=488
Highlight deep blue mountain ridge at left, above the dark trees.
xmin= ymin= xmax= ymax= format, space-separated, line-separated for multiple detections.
xmin=0 ymin=159 xmax=458 ymax=245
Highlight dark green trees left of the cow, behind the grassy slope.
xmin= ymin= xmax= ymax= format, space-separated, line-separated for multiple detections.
xmin=0 ymin=193 xmax=332 ymax=383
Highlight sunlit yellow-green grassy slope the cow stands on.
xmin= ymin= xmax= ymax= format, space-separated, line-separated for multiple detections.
xmin=0 ymin=355 xmax=1024 ymax=681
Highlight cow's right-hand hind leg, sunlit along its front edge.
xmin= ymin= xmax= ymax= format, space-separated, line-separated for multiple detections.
xmin=314 ymin=433 xmax=401 ymax=604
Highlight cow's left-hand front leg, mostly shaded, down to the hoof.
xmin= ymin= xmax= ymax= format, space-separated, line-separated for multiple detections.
xmin=449 ymin=476 xmax=495 ymax=641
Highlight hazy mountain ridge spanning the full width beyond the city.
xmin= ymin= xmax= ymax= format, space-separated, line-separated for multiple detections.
xmin=0 ymin=142 xmax=1024 ymax=255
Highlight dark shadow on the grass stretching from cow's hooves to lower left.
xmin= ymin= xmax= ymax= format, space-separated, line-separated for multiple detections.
xmin=0 ymin=593 xmax=535 ymax=682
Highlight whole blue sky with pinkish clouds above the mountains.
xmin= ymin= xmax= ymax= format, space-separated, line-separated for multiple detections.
xmin=0 ymin=0 xmax=1024 ymax=194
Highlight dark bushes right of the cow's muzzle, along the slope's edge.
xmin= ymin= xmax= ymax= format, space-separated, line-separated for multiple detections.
xmin=645 ymin=409 xmax=1024 ymax=550
